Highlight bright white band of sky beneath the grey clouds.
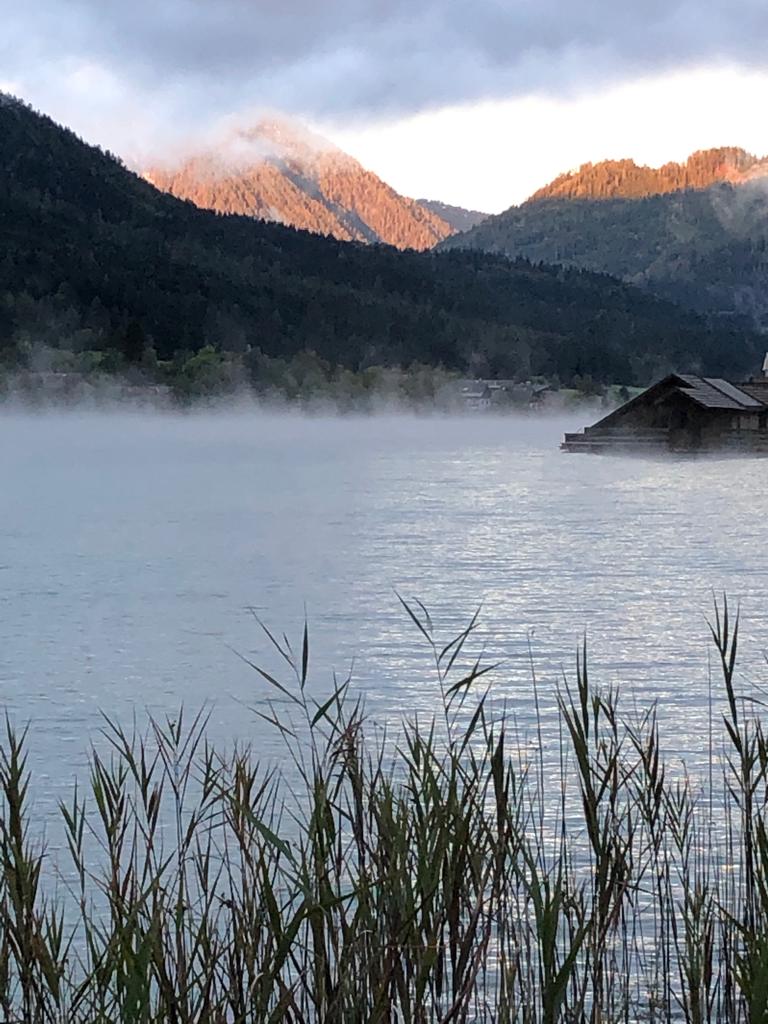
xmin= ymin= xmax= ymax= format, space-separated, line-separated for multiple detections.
xmin=325 ymin=68 xmax=768 ymax=213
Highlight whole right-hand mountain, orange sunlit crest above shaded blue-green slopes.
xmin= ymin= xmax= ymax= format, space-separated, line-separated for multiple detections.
xmin=438 ymin=150 xmax=768 ymax=331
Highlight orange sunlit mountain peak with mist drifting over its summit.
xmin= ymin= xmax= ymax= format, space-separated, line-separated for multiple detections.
xmin=144 ymin=121 xmax=455 ymax=250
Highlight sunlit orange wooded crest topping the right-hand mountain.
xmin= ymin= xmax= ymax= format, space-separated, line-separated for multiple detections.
xmin=530 ymin=146 xmax=768 ymax=201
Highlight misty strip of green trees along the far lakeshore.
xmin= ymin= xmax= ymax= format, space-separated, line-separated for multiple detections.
xmin=0 ymin=346 xmax=640 ymax=413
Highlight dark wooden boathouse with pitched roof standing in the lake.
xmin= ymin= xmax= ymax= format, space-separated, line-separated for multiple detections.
xmin=561 ymin=374 xmax=768 ymax=454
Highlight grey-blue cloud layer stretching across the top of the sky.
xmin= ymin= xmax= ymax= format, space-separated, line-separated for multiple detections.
xmin=0 ymin=0 xmax=768 ymax=147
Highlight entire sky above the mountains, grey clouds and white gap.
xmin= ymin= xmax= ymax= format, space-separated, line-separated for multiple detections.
xmin=0 ymin=0 xmax=768 ymax=213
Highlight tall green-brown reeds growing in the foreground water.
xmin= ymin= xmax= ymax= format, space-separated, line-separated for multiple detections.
xmin=0 ymin=602 xmax=768 ymax=1024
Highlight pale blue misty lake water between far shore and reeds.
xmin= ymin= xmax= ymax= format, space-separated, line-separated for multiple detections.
xmin=0 ymin=412 xmax=768 ymax=810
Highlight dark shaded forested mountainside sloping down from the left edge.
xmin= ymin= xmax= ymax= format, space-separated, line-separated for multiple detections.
xmin=0 ymin=98 xmax=763 ymax=384
